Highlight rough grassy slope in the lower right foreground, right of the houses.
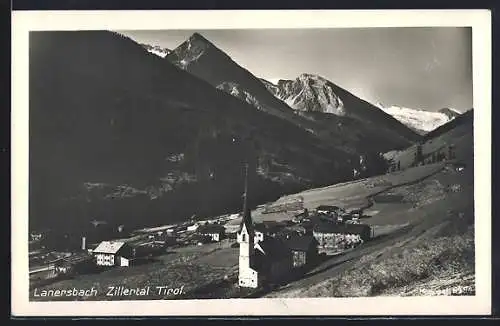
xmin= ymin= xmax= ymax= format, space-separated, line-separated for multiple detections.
xmin=267 ymin=143 xmax=475 ymax=297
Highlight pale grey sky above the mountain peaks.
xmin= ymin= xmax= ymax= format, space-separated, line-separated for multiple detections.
xmin=118 ymin=27 xmax=473 ymax=112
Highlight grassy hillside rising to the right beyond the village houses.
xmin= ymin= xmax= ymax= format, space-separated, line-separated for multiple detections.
xmin=265 ymin=106 xmax=476 ymax=298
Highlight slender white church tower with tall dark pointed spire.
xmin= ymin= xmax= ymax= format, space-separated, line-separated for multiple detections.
xmin=237 ymin=164 xmax=258 ymax=288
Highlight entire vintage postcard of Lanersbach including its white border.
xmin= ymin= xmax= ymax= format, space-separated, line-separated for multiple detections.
xmin=11 ymin=10 xmax=491 ymax=316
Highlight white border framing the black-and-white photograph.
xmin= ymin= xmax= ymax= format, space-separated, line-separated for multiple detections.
xmin=11 ymin=10 xmax=491 ymax=316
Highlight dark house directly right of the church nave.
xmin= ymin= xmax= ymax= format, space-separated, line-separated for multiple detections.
xmin=283 ymin=235 xmax=318 ymax=268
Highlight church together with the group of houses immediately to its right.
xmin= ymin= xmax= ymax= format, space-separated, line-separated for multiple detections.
xmin=237 ymin=166 xmax=371 ymax=288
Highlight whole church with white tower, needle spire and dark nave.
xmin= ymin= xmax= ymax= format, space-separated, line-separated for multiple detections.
xmin=237 ymin=166 xmax=293 ymax=288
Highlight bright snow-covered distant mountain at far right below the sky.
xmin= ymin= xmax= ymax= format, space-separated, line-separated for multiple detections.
xmin=378 ymin=103 xmax=460 ymax=134
